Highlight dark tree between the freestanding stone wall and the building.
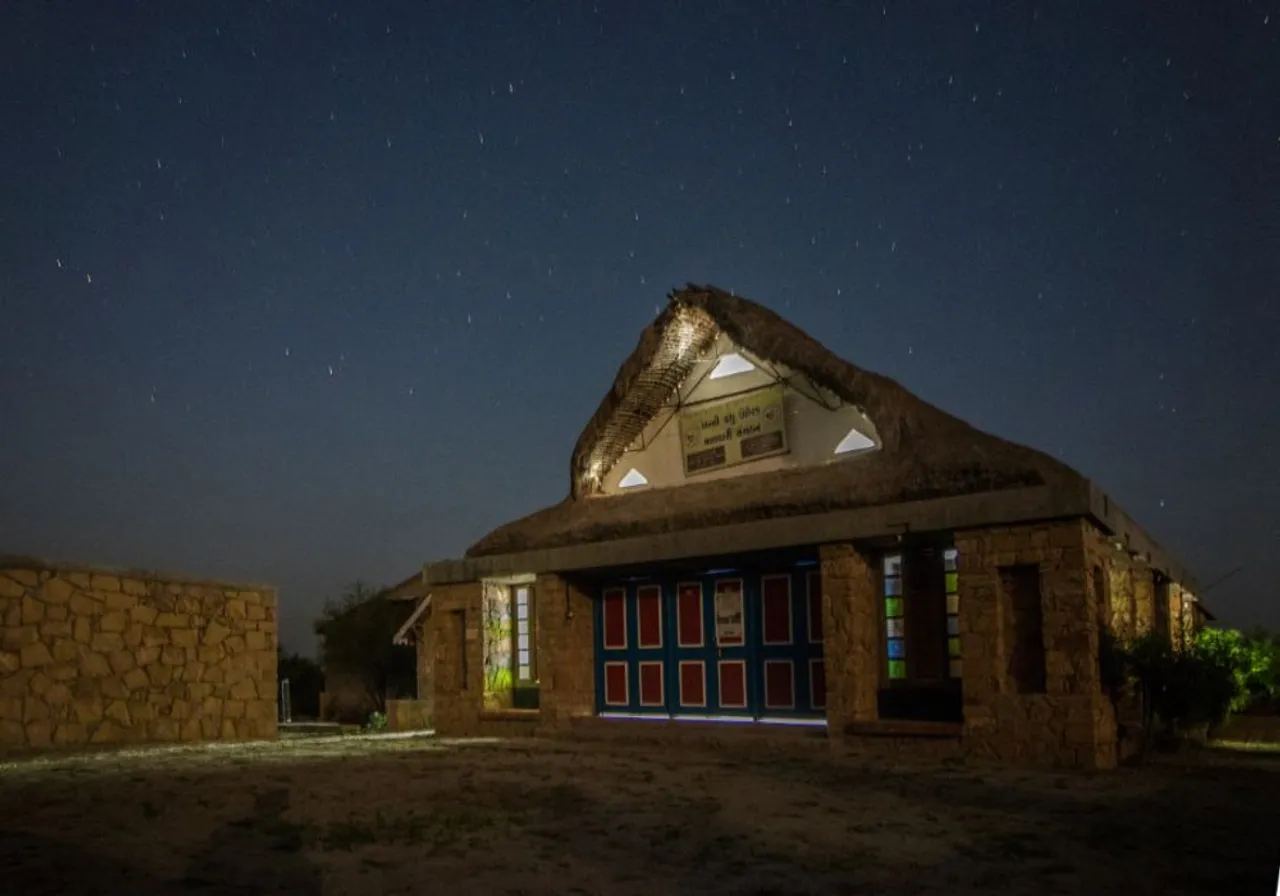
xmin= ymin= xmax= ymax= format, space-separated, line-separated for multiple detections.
xmin=315 ymin=580 xmax=417 ymax=713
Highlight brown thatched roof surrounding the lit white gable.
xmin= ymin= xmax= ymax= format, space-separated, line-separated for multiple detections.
xmin=467 ymin=284 xmax=1080 ymax=557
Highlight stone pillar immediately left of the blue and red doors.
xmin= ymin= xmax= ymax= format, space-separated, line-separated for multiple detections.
xmin=534 ymin=573 xmax=595 ymax=731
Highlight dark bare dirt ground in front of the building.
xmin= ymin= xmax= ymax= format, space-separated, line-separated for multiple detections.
xmin=0 ymin=737 xmax=1280 ymax=896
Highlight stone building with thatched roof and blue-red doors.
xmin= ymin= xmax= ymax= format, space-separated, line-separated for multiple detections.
xmin=389 ymin=285 xmax=1203 ymax=768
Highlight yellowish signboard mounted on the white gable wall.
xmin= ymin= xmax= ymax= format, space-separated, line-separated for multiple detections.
xmin=680 ymin=384 xmax=788 ymax=476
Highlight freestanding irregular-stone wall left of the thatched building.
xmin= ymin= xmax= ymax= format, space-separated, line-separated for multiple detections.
xmin=0 ymin=559 xmax=276 ymax=748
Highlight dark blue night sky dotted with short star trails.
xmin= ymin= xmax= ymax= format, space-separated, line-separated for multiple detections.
xmin=0 ymin=0 xmax=1280 ymax=652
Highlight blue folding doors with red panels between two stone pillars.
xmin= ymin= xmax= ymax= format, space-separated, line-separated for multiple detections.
xmin=595 ymin=562 xmax=826 ymax=719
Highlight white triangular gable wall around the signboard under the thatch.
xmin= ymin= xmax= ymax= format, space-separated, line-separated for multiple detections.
xmin=603 ymin=335 xmax=879 ymax=494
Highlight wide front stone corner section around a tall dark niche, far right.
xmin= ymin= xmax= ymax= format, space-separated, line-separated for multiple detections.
xmin=955 ymin=520 xmax=1116 ymax=768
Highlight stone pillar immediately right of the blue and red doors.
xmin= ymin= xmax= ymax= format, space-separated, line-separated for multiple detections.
xmin=819 ymin=544 xmax=881 ymax=739
